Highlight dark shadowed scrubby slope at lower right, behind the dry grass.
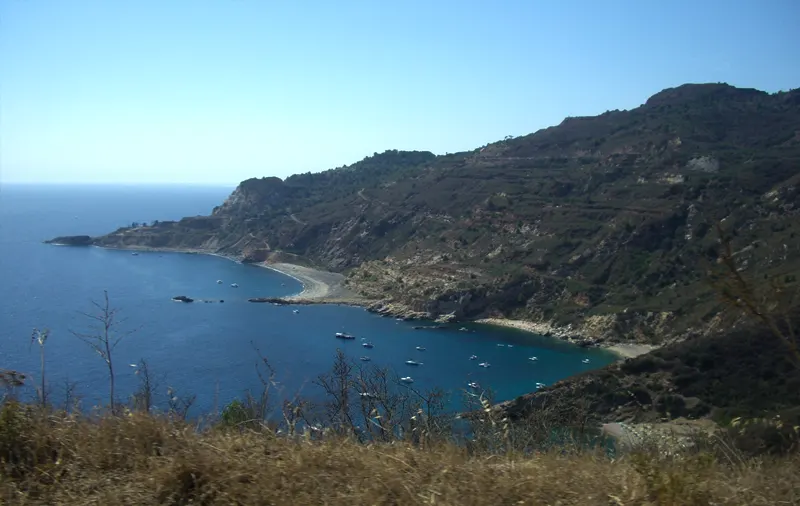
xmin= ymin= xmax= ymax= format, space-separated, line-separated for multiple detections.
xmin=497 ymin=313 xmax=800 ymax=434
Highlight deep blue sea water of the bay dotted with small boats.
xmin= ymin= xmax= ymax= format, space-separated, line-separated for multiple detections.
xmin=0 ymin=185 xmax=614 ymax=414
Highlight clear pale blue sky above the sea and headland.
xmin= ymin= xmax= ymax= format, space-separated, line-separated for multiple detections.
xmin=0 ymin=0 xmax=800 ymax=184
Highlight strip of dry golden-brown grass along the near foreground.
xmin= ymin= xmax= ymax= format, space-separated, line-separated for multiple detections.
xmin=0 ymin=403 xmax=800 ymax=506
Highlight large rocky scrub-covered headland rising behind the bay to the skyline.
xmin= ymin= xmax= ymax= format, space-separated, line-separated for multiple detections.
xmin=72 ymin=84 xmax=800 ymax=343
